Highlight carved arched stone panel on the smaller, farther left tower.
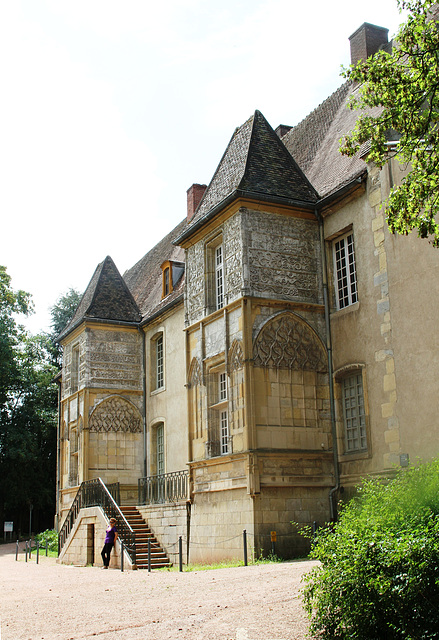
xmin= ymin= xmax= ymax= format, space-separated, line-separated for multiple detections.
xmin=89 ymin=396 xmax=142 ymax=433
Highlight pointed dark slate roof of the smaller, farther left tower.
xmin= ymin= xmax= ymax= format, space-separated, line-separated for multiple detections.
xmin=58 ymin=256 xmax=141 ymax=341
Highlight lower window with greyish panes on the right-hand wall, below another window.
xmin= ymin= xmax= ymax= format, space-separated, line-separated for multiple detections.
xmin=342 ymin=372 xmax=367 ymax=452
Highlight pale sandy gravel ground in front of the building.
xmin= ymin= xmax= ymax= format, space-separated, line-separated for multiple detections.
xmin=0 ymin=544 xmax=315 ymax=640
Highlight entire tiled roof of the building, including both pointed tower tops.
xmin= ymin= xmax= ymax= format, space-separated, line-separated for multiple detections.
xmin=60 ymin=35 xmax=398 ymax=338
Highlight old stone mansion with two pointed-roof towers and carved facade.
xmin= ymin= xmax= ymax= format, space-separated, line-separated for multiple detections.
xmin=57 ymin=24 xmax=439 ymax=561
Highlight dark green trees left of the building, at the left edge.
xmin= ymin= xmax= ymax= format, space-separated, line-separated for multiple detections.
xmin=0 ymin=267 xmax=79 ymax=534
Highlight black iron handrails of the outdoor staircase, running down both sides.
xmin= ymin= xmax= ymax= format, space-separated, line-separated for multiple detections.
xmin=58 ymin=478 xmax=136 ymax=565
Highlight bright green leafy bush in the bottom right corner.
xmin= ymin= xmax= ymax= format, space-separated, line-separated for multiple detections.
xmin=303 ymin=460 xmax=439 ymax=640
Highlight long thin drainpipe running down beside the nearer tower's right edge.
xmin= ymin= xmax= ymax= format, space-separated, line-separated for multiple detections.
xmin=315 ymin=209 xmax=340 ymax=522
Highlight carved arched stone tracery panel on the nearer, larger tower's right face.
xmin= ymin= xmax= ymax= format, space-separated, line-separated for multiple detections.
xmin=253 ymin=313 xmax=327 ymax=372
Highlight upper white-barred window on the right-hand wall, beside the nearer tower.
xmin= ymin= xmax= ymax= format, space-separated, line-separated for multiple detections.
xmin=334 ymin=233 xmax=358 ymax=309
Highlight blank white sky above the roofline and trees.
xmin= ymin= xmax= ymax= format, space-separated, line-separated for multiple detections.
xmin=0 ymin=0 xmax=408 ymax=332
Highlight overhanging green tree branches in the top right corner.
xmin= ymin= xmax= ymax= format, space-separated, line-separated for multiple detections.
xmin=341 ymin=0 xmax=439 ymax=247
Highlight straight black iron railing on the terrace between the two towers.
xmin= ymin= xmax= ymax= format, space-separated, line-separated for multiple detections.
xmin=138 ymin=470 xmax=189 ymax=504
